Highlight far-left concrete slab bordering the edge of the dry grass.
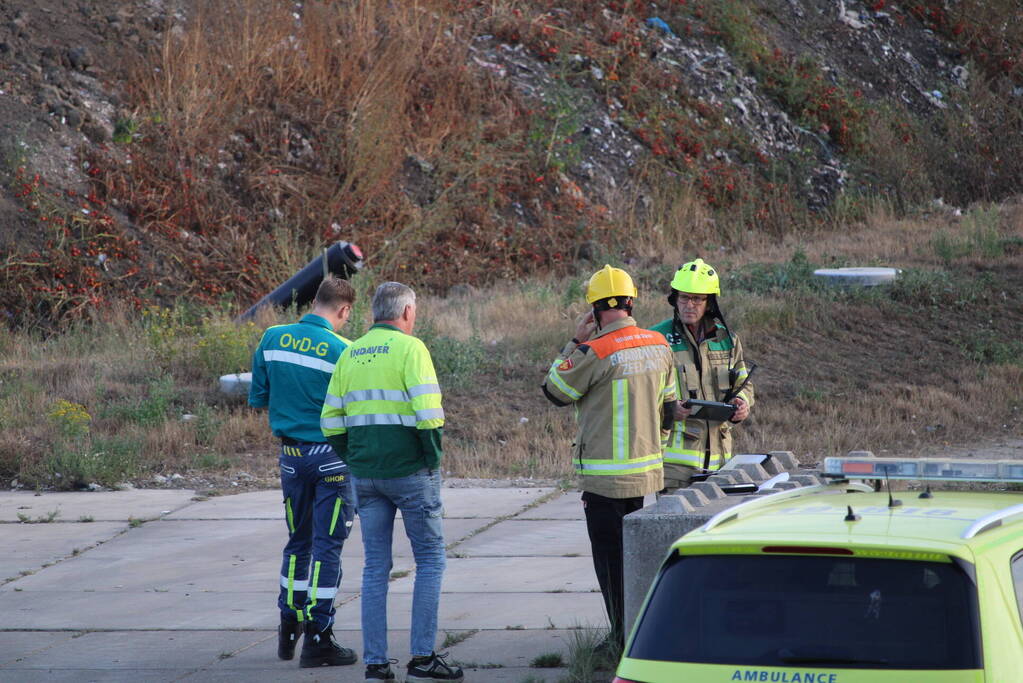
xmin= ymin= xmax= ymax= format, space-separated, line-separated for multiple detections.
xmin=0 ymin=489 xmax=195 ymax=521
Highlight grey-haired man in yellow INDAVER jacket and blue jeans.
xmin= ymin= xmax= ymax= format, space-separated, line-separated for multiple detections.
xmin=320 ymin=282 xmax=462 ymax=681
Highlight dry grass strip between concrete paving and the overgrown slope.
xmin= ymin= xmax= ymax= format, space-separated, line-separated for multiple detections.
xmin=0 ymin=204 xmax=1023 ymax=488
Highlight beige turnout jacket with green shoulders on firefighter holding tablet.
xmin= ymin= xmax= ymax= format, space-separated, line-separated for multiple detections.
xmin=653 ymin=318 xmax=753 ymax=476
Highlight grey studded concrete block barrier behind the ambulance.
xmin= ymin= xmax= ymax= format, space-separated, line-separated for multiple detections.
xmin=622 ymin=451 xmax=820 ymax=633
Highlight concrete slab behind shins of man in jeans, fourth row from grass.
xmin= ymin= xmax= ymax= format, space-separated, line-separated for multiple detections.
xmin=337 ymin=592 xmax=607 ymax=631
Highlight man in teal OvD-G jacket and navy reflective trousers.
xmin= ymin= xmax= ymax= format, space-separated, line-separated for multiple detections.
xmin=249 ymin=276 xmax=356 ymax=667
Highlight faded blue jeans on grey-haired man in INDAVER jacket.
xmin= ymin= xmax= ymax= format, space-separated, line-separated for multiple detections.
xmin=355 ymin=469 xmax=445 ymax=665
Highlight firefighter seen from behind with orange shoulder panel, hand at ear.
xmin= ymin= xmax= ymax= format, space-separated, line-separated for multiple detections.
xmin=543 ymin=266 xmax=676 ymax=651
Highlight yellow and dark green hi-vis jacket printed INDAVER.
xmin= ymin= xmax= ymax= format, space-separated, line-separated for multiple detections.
xmin=320 ymin=324 xmax=444 ymax=479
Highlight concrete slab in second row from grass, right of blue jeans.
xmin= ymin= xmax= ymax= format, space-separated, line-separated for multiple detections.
xmin=453 ymin=519 xmax=590 ymax=557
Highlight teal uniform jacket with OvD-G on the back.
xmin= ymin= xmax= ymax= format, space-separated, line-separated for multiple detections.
xmin=249 ymin=313 xmax=349 ymax=443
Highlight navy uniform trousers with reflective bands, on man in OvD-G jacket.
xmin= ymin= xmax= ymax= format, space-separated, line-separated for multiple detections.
xmin=277 ymin=440 xmax=355 ymax=630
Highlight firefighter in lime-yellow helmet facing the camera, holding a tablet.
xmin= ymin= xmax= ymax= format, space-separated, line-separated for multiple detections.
xmin=652 ymin=259 xmax=753 ymax=490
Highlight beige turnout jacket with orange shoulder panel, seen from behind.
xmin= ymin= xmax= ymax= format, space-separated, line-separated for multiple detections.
xmin=543 ymin=317 xmax=676 ymax=498
